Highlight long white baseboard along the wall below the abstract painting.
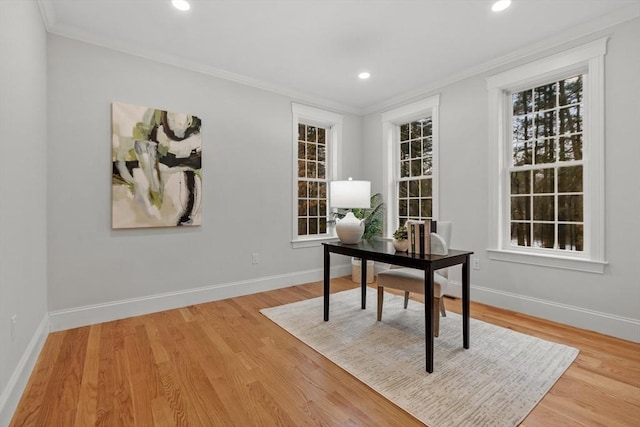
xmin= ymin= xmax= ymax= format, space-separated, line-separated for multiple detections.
xmin=49 ymin=265 xmax=351 ymax=332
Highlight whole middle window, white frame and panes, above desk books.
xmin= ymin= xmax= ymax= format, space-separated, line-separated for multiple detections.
xmin=382 ymin=95 xmax=440 ymax=236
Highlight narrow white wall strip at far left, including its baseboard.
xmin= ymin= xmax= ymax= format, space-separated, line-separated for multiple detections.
xmin=0 ymin=0 xmax=48 ymax=426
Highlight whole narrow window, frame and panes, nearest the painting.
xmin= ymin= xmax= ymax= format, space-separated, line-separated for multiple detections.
xmin=292 ymin=104 xmax=342 ymax=247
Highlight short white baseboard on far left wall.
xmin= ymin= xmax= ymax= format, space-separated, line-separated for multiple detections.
xmin=0 ymin=314 xmax=49 ymax=427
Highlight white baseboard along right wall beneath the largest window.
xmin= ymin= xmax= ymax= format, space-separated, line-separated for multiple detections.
xmin=449 ymin=281 xmax=640 ymax=342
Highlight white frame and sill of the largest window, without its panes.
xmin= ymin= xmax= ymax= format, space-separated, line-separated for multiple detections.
xmin=487 ymin=37 xmax=608 ymax=273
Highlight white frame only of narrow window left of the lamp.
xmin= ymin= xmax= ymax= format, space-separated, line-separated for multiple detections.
xmin=291 ymin=102 xmax=343 ymax=248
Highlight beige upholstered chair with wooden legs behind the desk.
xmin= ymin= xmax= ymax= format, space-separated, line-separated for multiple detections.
xmin=378 ymin=221 xmax=452 ymax=337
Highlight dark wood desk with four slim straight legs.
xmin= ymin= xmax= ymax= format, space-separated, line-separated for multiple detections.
xmin=323 ymin=240 xmax=473 ymax=372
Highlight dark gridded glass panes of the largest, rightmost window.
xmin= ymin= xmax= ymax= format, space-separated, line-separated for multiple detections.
xmin=509 ymin=75 xmax=584 ymax=252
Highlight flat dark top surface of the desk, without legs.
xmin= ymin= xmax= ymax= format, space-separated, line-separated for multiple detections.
xmin=323 ymin=239 xmax=473 ymax=269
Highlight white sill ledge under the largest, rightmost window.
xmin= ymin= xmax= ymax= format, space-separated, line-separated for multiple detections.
xmin=487 ymin=249 xmax=608 ymax=274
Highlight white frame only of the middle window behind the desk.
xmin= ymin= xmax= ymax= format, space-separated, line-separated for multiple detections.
xmin=381 ymin=94 xmax=440 ymax=238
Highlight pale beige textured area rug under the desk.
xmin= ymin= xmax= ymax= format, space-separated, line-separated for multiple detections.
xmin=261 ymin=289 xmax=578 ymax=427
